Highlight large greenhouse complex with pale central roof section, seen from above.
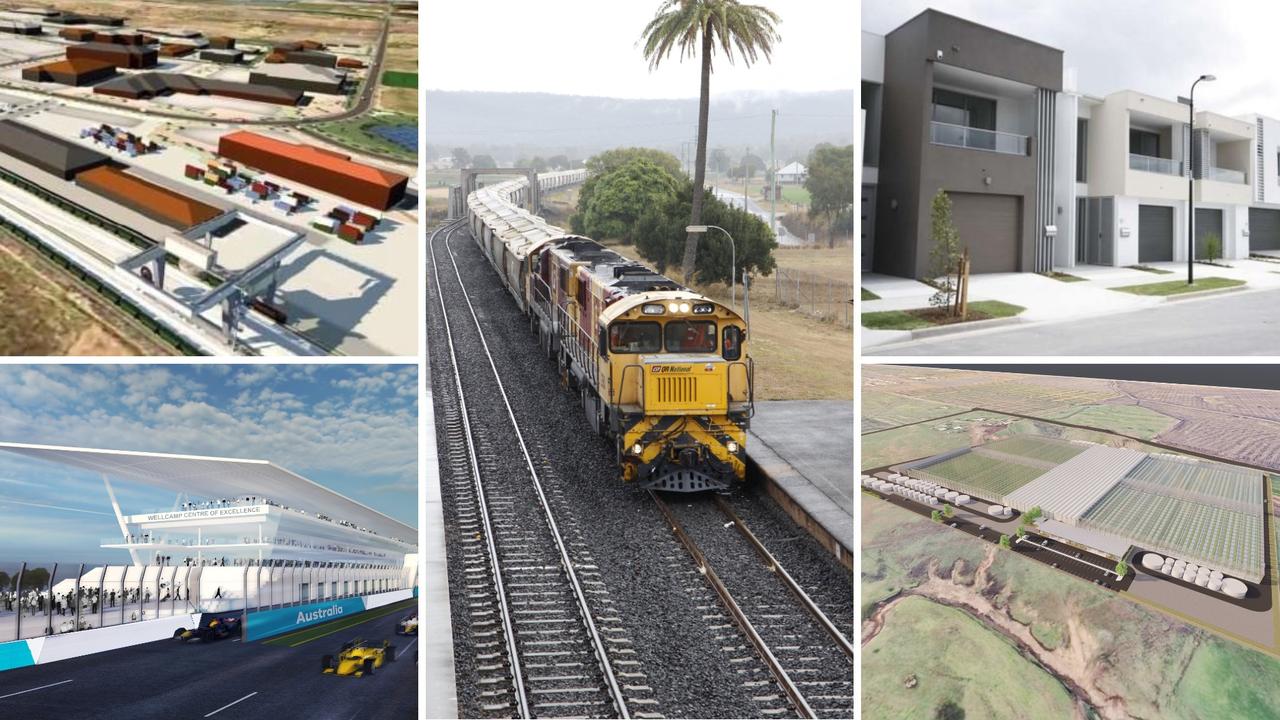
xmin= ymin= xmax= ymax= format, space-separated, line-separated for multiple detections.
xmin=895 ymin=436 xmax=1266 ymax=583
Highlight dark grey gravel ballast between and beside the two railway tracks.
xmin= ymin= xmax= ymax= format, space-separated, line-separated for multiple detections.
xmin=428 ymin=221 xmax=851 ymax=717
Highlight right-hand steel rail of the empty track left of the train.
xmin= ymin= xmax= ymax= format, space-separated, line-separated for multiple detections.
xmin=431 ymin=220 xmax=631 ymax=720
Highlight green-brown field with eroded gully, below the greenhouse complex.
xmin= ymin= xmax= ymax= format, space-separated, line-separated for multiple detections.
xmin=861 ymin=496 xmax=1280 ymax=720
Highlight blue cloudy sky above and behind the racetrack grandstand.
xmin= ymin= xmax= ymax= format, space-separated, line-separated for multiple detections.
xmin=0 ymin=364 xmax=417 ymax=562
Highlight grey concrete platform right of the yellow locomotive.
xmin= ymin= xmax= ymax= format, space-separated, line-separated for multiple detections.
xmin=746 ymin=400 xmax=854 ymax=569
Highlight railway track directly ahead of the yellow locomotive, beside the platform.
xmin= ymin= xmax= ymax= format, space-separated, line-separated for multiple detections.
xmin=649 ymin=491 xmax=854 ymax=717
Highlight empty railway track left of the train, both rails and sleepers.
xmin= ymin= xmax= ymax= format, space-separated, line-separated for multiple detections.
xmin=428 ymin=222 xmax=634 ymax=717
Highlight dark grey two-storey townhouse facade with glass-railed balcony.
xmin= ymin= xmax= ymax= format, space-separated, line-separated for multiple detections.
xmin=864 ymin=10 xmax=1062 ymax=278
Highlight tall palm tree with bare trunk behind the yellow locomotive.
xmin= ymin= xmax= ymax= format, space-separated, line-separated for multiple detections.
xmin=641 ymin=0 xmax=781 ymax=281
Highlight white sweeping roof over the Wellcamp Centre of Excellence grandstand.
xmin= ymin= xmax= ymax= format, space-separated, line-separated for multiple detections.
xmin=0 ymin=442 xmax=417 ymax=544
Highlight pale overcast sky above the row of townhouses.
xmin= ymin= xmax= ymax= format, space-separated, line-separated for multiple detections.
xmin=861 ymin=0 xmax=1280 ymax=117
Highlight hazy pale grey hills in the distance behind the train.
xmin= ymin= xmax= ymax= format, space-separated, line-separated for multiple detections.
xmin=426 ymin=90 xmax=855 ymax=165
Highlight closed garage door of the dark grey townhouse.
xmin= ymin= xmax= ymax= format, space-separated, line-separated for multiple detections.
xmin=951 ymin=192 xmax=1021 ymax=273
